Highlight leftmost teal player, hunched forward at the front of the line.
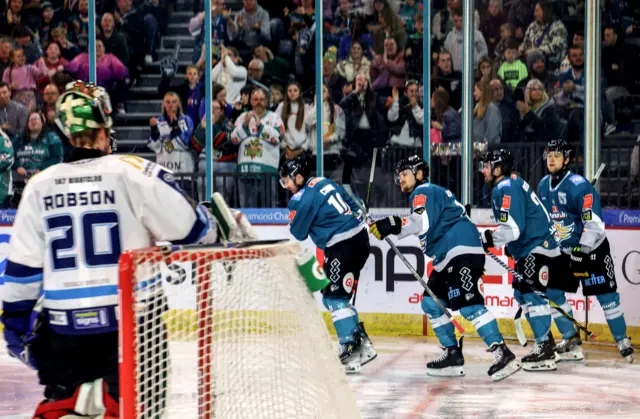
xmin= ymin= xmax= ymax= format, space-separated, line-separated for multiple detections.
xmin=280 ymin=156 xmax=377 ymax=373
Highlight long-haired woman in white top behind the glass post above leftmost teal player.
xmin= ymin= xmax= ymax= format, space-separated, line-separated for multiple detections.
xmin=306 ymin=85 xmax=346 ymax=181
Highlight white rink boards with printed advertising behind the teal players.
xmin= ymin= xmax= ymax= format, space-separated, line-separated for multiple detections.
xmin=0 ymin=209 xmax=640 ymax=344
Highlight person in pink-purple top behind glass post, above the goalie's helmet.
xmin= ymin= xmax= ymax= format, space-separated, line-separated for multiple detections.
xmin=65 ymin=39 xmax=129 ymax=114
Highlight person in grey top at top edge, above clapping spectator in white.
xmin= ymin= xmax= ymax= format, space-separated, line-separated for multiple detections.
xmin=228 ymin=0 xmax=271 ymax=58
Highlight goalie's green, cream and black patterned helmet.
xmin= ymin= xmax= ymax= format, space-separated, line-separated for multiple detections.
xmin=56 ymin=80 xmax=113 ymax=137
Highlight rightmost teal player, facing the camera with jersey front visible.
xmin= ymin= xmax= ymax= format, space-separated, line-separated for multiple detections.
xmin=538 ymin=140 xmax=633 ymax=362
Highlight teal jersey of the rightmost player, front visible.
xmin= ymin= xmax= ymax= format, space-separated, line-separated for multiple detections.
xmin=538 ymin=171 xmax=606 ymax=253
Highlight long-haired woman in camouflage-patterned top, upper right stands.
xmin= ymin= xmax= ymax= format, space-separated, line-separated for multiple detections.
xmin=519 ymin=0 xmax=567 ymax=70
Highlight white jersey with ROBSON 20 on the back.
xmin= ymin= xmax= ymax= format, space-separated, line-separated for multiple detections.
xmin=3 ymin=156 xmax=216 ymax=334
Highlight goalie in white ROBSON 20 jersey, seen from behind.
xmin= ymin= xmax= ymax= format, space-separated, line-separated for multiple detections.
xmin=2 ymin=82 xmax=255 ymax=419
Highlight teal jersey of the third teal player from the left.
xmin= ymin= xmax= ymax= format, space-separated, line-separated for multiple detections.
xmin=491 ymin=174 xmax=559 ymax=261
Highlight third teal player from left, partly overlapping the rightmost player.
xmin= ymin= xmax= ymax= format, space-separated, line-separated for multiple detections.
xmin=481 ymin=149 xmax=560 ymax=371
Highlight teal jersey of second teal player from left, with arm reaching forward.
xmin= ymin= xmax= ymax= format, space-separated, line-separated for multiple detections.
xmin=398 ymin=183 xmax=484 ymax=271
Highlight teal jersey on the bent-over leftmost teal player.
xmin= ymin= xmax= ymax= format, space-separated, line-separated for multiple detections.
xmin=289 ymin=177 xmax=366 ymax=250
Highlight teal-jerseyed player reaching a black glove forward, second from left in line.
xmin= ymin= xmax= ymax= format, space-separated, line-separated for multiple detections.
xmin=370 ymin=156 xmax=521 ymax=381
